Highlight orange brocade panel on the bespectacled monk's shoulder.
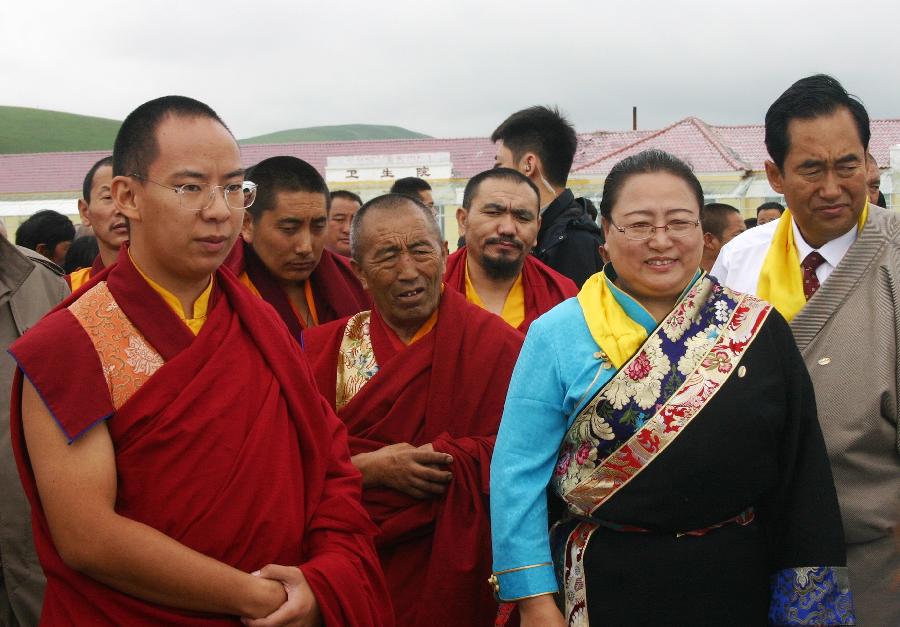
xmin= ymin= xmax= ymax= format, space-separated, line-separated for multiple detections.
xmin=69 ymin=281 xmax=165 ymax=410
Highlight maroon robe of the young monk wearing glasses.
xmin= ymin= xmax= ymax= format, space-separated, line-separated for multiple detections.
xmin=11 ymin=253 xmax=393 ymax=625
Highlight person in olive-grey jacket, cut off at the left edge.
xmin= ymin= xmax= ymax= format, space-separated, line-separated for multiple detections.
xmin=0 ymin=235 xmax=69 ymax=625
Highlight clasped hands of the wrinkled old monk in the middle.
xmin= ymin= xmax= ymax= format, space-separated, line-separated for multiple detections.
xmin=352 ymin=442 xmax=453 ymax=499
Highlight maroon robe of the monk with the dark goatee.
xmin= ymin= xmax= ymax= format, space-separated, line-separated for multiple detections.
xmin=444 ymin=246 xmax=578 ymax=333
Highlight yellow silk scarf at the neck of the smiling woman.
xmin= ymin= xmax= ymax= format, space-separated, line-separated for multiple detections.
xmin=578 ymin=272 xmax=647 ymax=370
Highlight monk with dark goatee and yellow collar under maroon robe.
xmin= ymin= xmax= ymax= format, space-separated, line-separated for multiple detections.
xmin=444 ymin=168 xmax=578 ymax=333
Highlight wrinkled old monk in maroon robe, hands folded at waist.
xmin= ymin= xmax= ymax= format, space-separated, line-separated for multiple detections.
xmin=303 ymin=194 xmax=522 ymax=627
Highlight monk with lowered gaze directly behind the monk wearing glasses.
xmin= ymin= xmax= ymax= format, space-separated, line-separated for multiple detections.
xmin=225 ymin=157 xmax=370 ymax=341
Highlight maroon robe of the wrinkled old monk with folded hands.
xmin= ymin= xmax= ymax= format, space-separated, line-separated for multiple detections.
xmin=304 ymin=290 xmax=523 ymax=627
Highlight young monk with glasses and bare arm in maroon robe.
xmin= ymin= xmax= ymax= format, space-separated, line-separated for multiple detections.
xmin=10 ymin=96 xmax=393 ymax=627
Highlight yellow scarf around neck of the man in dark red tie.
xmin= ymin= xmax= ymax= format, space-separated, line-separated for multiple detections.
xmin=756 ymin=200 xmax=869 ymax=322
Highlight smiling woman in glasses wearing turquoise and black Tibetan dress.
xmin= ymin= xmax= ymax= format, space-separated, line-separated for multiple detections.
xmin=491 ymin=151 xmax=854 ymax=627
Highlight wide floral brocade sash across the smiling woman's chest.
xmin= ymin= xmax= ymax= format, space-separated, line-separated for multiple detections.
xmin=552 ymin=276 xmax=771 ymax=518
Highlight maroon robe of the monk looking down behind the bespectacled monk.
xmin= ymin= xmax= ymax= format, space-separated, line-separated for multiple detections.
xmin=225 ymin=239 xmax=372 ymax=341
